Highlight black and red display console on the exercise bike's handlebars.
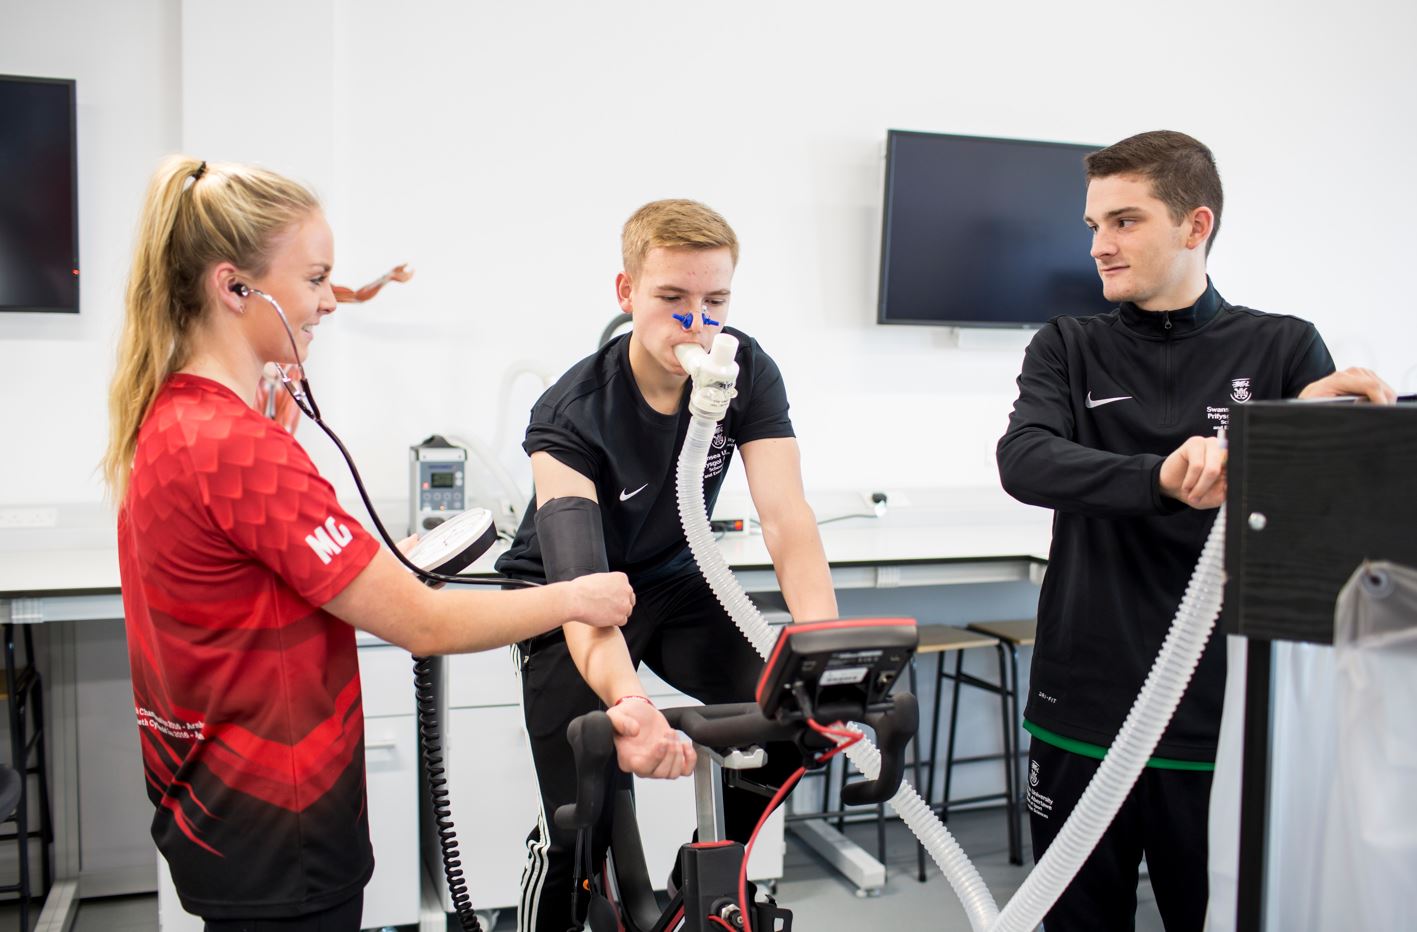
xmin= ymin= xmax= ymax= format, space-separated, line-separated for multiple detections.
xmin=757 ymin=618 xmax=918 ymax=724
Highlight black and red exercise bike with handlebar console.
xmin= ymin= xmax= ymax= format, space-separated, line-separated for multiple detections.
xmin=554 ymin=618 xmax=918 ymax=932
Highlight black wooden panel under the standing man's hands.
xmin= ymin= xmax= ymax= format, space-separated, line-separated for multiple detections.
xmin=1226 ymin=402 xmax=1417 ymax=644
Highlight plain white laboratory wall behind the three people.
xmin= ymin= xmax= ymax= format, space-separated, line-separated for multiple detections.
xmin=0 ymin=0 xmax=1417 ymax=503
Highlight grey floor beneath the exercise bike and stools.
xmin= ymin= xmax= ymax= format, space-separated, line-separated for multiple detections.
xmin=0 ymin=810 xmax=1162 ymax=932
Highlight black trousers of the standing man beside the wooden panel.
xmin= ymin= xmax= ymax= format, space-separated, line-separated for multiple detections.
xmin=1024 ymin=738 xmax=1212 ymax=932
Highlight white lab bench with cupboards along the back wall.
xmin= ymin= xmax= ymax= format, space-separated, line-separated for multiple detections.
xmin=0 ymin=487 xmax=1051 ymax=932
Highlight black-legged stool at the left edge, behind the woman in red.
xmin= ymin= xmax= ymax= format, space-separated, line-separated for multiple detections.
xmin=0 ymin=623 xmax=54 ymax=929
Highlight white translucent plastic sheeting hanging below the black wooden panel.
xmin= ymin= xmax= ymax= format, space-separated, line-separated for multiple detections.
xmin=1206 ymin=564 xmax=1417 ymax=932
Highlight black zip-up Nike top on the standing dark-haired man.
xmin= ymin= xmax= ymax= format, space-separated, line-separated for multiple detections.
xmin=998 ymin=282 xmax=1333 ymax=761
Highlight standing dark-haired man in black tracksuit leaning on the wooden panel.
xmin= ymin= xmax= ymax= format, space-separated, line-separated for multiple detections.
xmin=998 ymin=132 xmax=1393 ymax=932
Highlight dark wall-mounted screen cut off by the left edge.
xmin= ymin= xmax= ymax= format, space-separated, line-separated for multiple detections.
xmin=0 ymin=75 xmax=79 ymax=314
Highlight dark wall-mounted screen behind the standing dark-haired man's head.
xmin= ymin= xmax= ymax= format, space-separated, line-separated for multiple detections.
xmin=876 ymin=129 xmax=1112 ymax=329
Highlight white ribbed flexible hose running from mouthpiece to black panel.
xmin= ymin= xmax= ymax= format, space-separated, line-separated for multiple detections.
xmin=677 ymin=379 xmax=1226 ymax=932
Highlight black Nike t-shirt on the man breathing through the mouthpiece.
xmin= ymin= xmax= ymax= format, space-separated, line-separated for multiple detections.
xmin=497 ymin=327 xmax=794 ymax=585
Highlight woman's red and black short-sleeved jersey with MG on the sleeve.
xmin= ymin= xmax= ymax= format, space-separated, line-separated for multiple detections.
xmin=118 ymin=374 xmax=378 ymax=918
